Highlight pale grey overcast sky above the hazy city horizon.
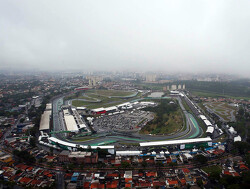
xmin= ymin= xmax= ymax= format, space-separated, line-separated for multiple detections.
xmin=0 ymin=0 xmax=250 ymax=76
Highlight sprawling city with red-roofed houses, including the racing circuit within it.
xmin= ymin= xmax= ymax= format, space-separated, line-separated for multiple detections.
xmin=0 ymin=72 xmax=250 ymax=189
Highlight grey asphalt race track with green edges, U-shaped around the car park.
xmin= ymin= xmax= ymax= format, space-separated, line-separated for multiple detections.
xmin=52 ymin=97 xmax=203 ymax=145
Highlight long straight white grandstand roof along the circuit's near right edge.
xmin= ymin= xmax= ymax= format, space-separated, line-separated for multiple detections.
xmin=140 ymin=137 xmax=212 ymax=146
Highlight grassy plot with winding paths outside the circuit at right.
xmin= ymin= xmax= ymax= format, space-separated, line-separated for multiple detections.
xmin=203 ymin=102 xmax=237 ymax=121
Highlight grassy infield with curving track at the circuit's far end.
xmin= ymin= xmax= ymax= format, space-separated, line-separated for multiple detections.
xmin=68 ymin=90 xmax=141 ymax=109
